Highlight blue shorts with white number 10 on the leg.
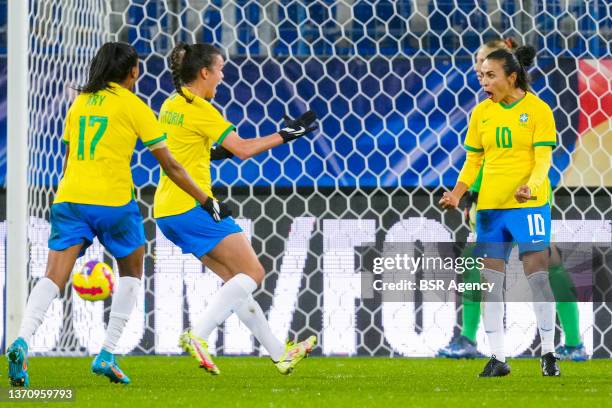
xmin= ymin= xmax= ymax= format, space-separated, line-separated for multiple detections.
xmin=474 ymin=204 xmax=550 ymax=262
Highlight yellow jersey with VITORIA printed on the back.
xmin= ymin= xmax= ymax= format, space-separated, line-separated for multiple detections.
xmin=153 ymin=87 xmax=235 ymax=218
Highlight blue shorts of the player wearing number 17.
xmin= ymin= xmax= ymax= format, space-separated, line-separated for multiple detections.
xmin=49 ymin=200 xmax=145 ymax=258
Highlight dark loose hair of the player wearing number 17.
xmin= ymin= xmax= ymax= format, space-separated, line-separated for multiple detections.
xmin=76 ymin=42 xmax=138 ymax=93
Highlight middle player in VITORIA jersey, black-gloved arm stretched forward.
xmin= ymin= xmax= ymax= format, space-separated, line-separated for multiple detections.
xmin=154 ymin=44 xmax=316 ymax=374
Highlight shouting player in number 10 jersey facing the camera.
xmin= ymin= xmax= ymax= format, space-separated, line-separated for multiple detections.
xmin=440 ymin=43 xmax=559 ymax=377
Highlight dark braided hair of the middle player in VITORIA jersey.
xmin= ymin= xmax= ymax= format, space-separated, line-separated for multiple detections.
xmin=168 ymin=43 xmax=222 ymax=103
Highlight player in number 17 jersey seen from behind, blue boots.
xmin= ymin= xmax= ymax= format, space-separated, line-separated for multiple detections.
xmin=7 ymin=42 xmax=218 ymax=387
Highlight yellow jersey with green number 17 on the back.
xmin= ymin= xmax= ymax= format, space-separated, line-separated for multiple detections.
xmin=54 ymin=82 xmax=166 ymax=207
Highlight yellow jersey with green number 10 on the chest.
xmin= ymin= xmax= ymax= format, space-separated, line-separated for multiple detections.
xmin=458 ymin=92 xmax=557 ymax=210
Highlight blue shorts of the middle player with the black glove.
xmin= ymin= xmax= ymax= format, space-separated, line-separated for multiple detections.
xmin=155 ymin=206 xmax=242 ymax=259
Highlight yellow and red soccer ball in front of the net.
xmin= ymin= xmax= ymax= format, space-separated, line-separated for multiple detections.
xmin=72 ymin=261 xmax=115 ymax=301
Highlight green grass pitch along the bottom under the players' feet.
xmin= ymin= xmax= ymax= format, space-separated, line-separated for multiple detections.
xmin=5 ymin=356 xmax=612 ymax=408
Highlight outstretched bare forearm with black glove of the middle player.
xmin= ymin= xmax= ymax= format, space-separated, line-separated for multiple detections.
xmin=223 ymin=111 xmax=317 ymax=160
